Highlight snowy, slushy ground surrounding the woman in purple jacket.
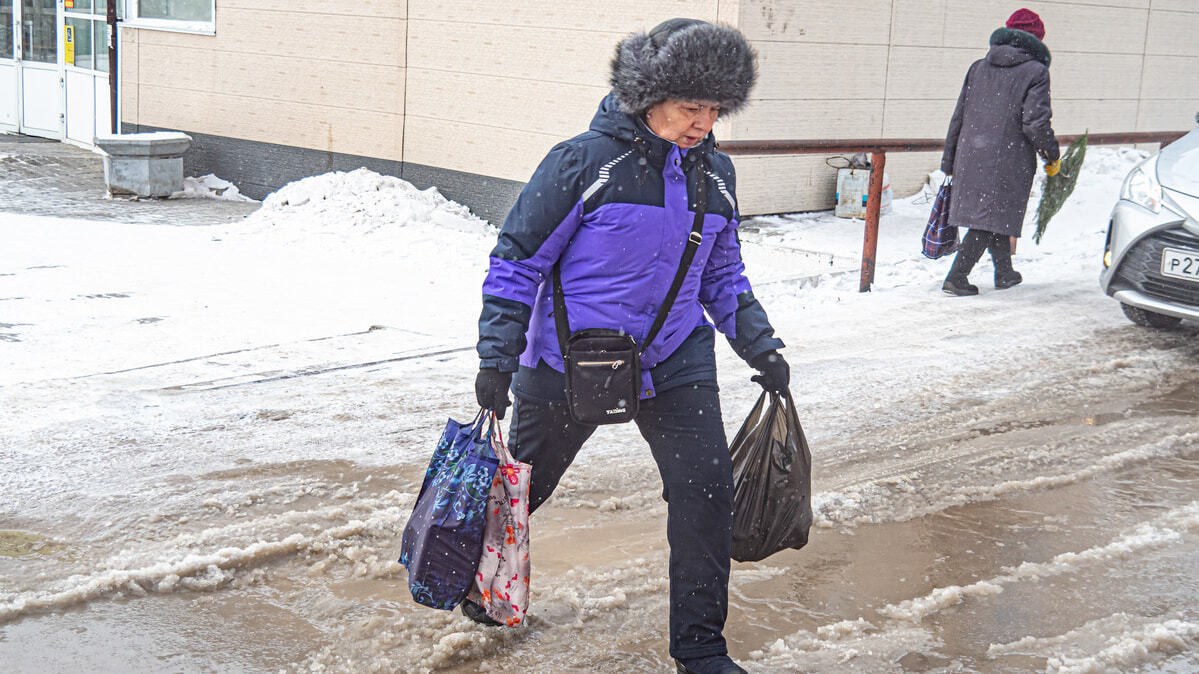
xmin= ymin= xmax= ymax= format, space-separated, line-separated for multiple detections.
xmin=0 ymin=149 xmax=1199 ymax=673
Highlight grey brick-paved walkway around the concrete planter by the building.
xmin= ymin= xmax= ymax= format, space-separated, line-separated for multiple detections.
xmin=0 ymin=133 xmax=258 ymax=225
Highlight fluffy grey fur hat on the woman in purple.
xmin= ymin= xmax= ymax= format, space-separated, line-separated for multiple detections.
xmin=611 ymin=19 xmax=758 ymax=115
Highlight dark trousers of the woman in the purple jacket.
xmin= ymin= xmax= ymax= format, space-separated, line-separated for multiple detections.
xmin=508 ymin=383 xmax=733 ymax=658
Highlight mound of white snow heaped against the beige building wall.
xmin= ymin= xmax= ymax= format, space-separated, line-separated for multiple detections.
xmin=247 ymin=168 xmax=489 ymax=234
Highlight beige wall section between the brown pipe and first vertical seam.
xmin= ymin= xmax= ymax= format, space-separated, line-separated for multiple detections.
xmin=121 ymin=0 xmax=408 ymax=160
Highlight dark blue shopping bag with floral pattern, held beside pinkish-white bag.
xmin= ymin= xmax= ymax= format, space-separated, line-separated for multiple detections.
xmin=399 ymin=411 xmax=500 ymax=610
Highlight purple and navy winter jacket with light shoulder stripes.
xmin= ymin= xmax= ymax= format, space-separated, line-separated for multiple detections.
xmin=478 ymin=95 xmax=783 ymax=396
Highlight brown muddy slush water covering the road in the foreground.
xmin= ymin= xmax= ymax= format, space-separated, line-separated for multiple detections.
xmin=0 ymin=366 xmax=1199 ymax=673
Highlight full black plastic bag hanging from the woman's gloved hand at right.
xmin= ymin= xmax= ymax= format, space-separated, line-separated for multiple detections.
xmin=729 ymin=391 xmax=812 ymax=561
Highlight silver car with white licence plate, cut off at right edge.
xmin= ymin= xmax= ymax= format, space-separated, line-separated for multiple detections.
xmin=1099 ymin=115 xmax=1199 ymax=327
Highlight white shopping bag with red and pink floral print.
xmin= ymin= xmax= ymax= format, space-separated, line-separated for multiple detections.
xmin=468 ymin=424 xmax=532 ymax=627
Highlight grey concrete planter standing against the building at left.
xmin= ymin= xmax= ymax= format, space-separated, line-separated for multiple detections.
xmin=96 ymin=131 xmax=192 ymax=197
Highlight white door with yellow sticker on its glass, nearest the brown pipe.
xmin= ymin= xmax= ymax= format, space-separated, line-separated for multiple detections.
xmin=62 ymin=0 xmax=112 ymax=145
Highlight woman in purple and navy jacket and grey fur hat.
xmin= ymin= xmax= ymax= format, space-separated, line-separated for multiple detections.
xmin=462 ymin=19 xmax=789 ymax=674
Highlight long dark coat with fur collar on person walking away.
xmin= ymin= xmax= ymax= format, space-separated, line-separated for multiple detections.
xmin=941 ymin=28 xmax=1060 ymax=236
